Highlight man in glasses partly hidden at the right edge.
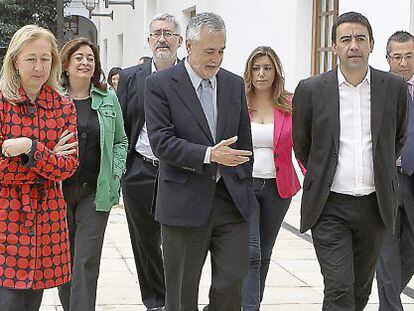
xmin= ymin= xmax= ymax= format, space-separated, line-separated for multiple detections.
xmin=377 ymin=31 xmax=414 ymax=311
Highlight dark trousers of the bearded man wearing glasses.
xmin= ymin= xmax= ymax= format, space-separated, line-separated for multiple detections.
xmin=122 ymin=154 xmax=165 ymax=309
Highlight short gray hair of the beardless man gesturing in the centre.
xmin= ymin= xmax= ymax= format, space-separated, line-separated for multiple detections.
xmin=186 ymin=13 xmax=226 ymax=41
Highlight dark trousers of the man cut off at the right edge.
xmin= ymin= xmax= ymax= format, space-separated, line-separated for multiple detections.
xmin=377 ymin=174 xmax=414 ymax=311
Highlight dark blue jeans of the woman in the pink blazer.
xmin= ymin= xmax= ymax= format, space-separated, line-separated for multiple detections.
xmin=243 ymin=178 xmax=291 ymax=311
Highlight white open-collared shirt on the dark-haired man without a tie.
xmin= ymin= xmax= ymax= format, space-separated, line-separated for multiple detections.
xmin=331 ymin=68 xmax=375 ymax=196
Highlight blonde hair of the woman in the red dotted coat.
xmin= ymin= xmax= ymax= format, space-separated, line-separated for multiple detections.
xmin=0 ymin=25 xmax=62 ymax=102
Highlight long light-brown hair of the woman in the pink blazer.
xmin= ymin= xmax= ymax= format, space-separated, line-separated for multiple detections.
xmin=244 ymin=46 xmax=292 ymax=113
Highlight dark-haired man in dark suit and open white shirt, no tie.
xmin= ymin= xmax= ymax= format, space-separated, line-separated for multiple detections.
xmin=293 ymin=12 xmax=407 ymax=311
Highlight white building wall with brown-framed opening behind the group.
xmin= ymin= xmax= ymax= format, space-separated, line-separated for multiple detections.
xmin=65 ymin=0 xmax=414 ymax=91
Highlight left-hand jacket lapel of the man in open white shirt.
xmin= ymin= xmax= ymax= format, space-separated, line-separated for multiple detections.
xmin=322 ymin=68 xmax=340 ymax=152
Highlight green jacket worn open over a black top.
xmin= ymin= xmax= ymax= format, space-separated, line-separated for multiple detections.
xmin=91 ymin=86 xmax=128 ymax=212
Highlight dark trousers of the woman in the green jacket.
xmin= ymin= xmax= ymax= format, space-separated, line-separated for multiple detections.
xmin=59 ymin=185 xmax=109 ymax=311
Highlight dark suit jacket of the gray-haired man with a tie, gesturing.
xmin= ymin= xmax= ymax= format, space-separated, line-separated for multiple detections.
xmin=145 ymin=62 xmax=254 ymax=226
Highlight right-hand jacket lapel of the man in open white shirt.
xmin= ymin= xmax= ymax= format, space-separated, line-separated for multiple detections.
xmin=370 ymin=67 xmax=386 ymax=155
